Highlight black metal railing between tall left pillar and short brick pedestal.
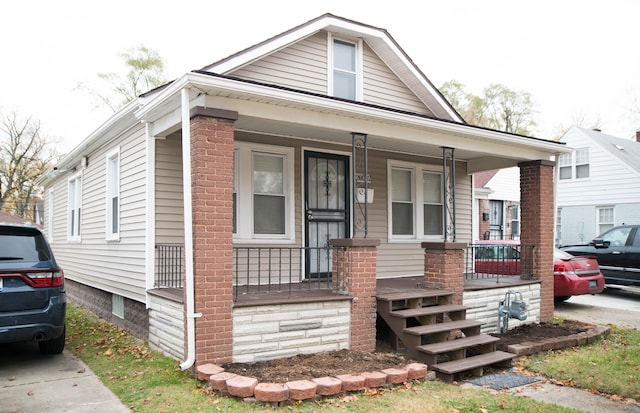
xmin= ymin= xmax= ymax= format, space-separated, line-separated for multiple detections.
xmin=233 ymin=247 xmax=339 ymax=299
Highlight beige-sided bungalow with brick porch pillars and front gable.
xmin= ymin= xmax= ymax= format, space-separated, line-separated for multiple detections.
xmin=42 ymin=14 xmax=569 ymax=376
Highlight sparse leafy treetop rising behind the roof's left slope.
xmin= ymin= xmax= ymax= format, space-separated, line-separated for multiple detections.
xmin=78 ymin=45 xmax=166 ymax=112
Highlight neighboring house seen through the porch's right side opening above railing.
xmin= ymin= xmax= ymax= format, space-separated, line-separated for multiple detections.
xmin=473 ymin=168 xmax=520 ymax=240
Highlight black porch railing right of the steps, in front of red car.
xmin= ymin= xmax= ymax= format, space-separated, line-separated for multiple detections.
xmin=464 ymin=242 xmax=535 ymax=281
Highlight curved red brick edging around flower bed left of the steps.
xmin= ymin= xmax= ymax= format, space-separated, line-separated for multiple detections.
xmin=196 ymin=363 xmax=435 ymax=403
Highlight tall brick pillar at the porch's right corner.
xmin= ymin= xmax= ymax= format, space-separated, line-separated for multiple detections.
xmin=518 ymin=160 xmax=555 ymax=321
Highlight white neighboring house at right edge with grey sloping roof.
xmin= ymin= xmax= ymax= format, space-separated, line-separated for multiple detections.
xmin=556 ymin=126 xmax=640 ymax=245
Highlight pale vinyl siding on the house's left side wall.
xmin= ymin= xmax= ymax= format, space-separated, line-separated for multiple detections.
xmin=49 ymin=124 xmax=147 ymax=302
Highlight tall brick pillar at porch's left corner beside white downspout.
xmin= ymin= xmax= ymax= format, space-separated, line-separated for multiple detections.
xmin=191 ymin=107 xmax=238 ymax=365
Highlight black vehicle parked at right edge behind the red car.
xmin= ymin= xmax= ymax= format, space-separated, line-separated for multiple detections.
xmin=561 ymin=225 xmax=640 ymax=286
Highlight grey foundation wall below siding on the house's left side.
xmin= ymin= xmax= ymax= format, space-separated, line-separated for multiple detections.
xmin=65 ymin=279 xmax=149 ymax=341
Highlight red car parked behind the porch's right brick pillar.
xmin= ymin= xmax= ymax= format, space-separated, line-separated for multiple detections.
xmin=474 ymin=241 xmax=605 ymax=301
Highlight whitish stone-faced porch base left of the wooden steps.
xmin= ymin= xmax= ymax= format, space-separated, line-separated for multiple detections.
xmin=233 ymin=297 xmax=350 ymax=363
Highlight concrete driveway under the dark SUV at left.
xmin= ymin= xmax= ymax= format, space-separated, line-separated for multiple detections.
xmin=0 ymin=342 xmax=129 ymax=413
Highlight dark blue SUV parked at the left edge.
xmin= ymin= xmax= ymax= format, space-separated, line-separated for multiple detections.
xmin=0 ymin=223 xmax=67 ymax=354
